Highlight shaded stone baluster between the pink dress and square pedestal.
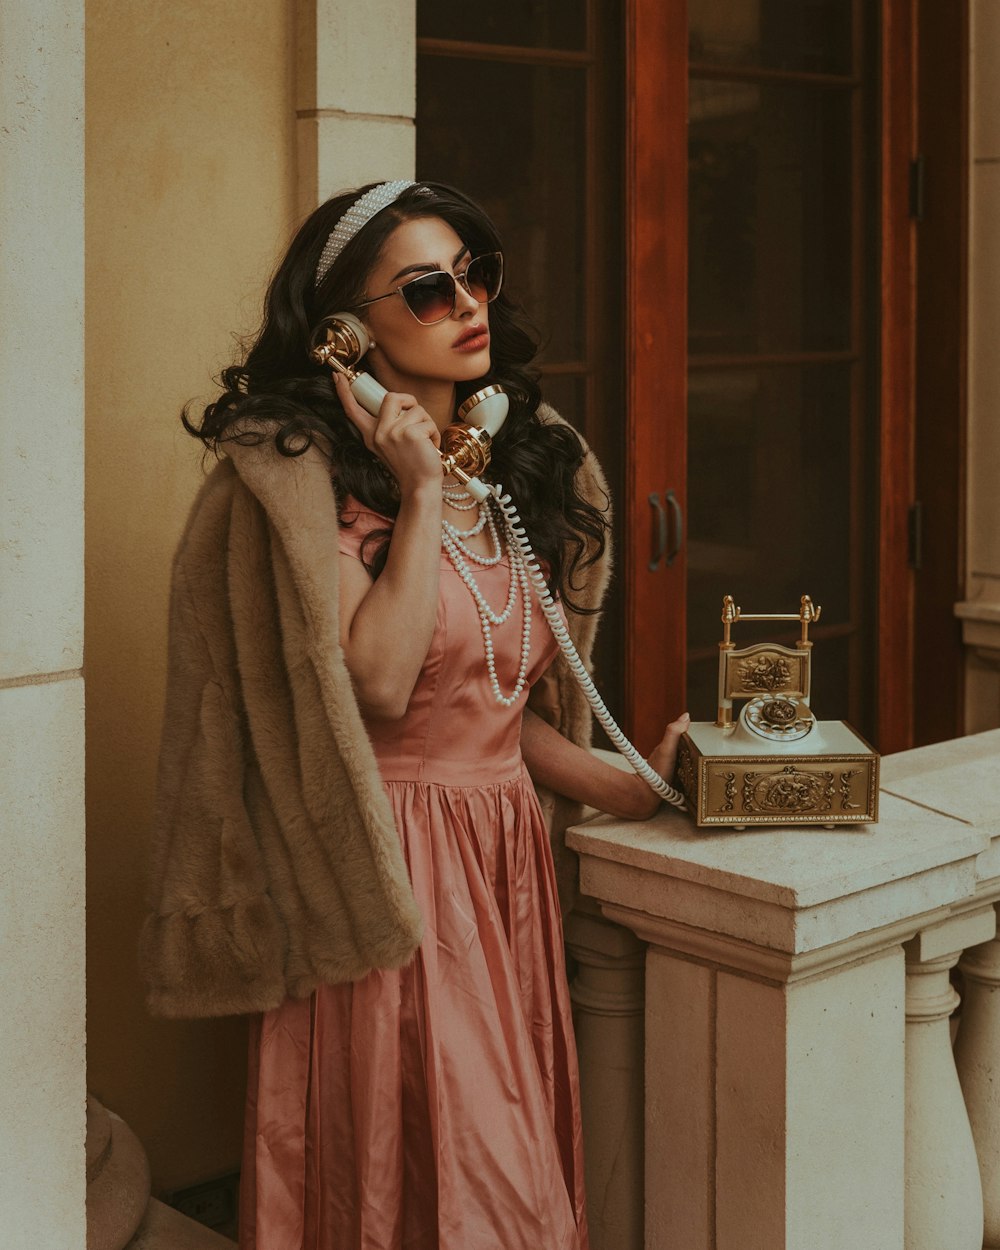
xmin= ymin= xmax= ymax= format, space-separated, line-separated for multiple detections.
xmin=566 ymin=911 xmax=645 ymax=1250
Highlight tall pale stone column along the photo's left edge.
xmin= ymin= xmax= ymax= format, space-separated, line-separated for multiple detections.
xmin=0 ymin=0 xmax=86 ymax=1250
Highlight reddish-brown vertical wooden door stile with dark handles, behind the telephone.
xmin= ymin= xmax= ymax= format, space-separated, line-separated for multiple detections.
xmin=621 ymin=0 xmax=688 ymax=751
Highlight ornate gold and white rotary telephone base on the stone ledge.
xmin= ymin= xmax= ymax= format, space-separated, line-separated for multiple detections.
xmin=678 ymin=595 xmax=879 ymax=829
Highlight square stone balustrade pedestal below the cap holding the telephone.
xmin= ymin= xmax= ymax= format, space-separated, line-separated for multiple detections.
xmin=606 ymin=906 xmax=904 ymax=1250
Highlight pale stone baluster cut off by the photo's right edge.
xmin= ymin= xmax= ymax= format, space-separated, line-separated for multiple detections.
xmin=955 ymin=910 xmax=1000 ymax=1250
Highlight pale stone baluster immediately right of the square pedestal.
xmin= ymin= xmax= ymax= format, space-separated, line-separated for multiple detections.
xmin=905 ymin=906 xmax=996 ymax=1250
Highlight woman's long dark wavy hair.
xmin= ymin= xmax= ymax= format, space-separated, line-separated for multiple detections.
xmin=181 ymin=183 xmax=608 ymax=611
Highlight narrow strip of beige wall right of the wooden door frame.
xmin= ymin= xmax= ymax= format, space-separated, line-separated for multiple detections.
xmin=959 ymin=0 xmax=1000 ymax=733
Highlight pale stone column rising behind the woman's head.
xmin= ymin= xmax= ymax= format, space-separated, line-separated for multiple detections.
xmin=296 ymin=0 xmax=416 ymax=214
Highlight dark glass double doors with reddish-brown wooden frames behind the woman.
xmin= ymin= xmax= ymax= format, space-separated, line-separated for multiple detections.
xmin=418 ymin=0 xmax=916 ymax=751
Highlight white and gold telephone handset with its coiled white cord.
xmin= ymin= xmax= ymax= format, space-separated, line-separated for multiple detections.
xmin=310 ymin=313 xmax=686 ymax=811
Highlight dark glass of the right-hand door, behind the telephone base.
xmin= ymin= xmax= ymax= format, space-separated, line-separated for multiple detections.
xmin=688 ymin=0 xmax=878 ymax=733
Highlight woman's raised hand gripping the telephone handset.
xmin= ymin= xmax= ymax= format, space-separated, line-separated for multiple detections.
xmin=334 ymin=374 xmax=441 ymax=495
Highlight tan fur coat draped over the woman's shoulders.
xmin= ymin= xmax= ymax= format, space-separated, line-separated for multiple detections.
xmin=140 ymin=410 xmax=609 ymax=1016
